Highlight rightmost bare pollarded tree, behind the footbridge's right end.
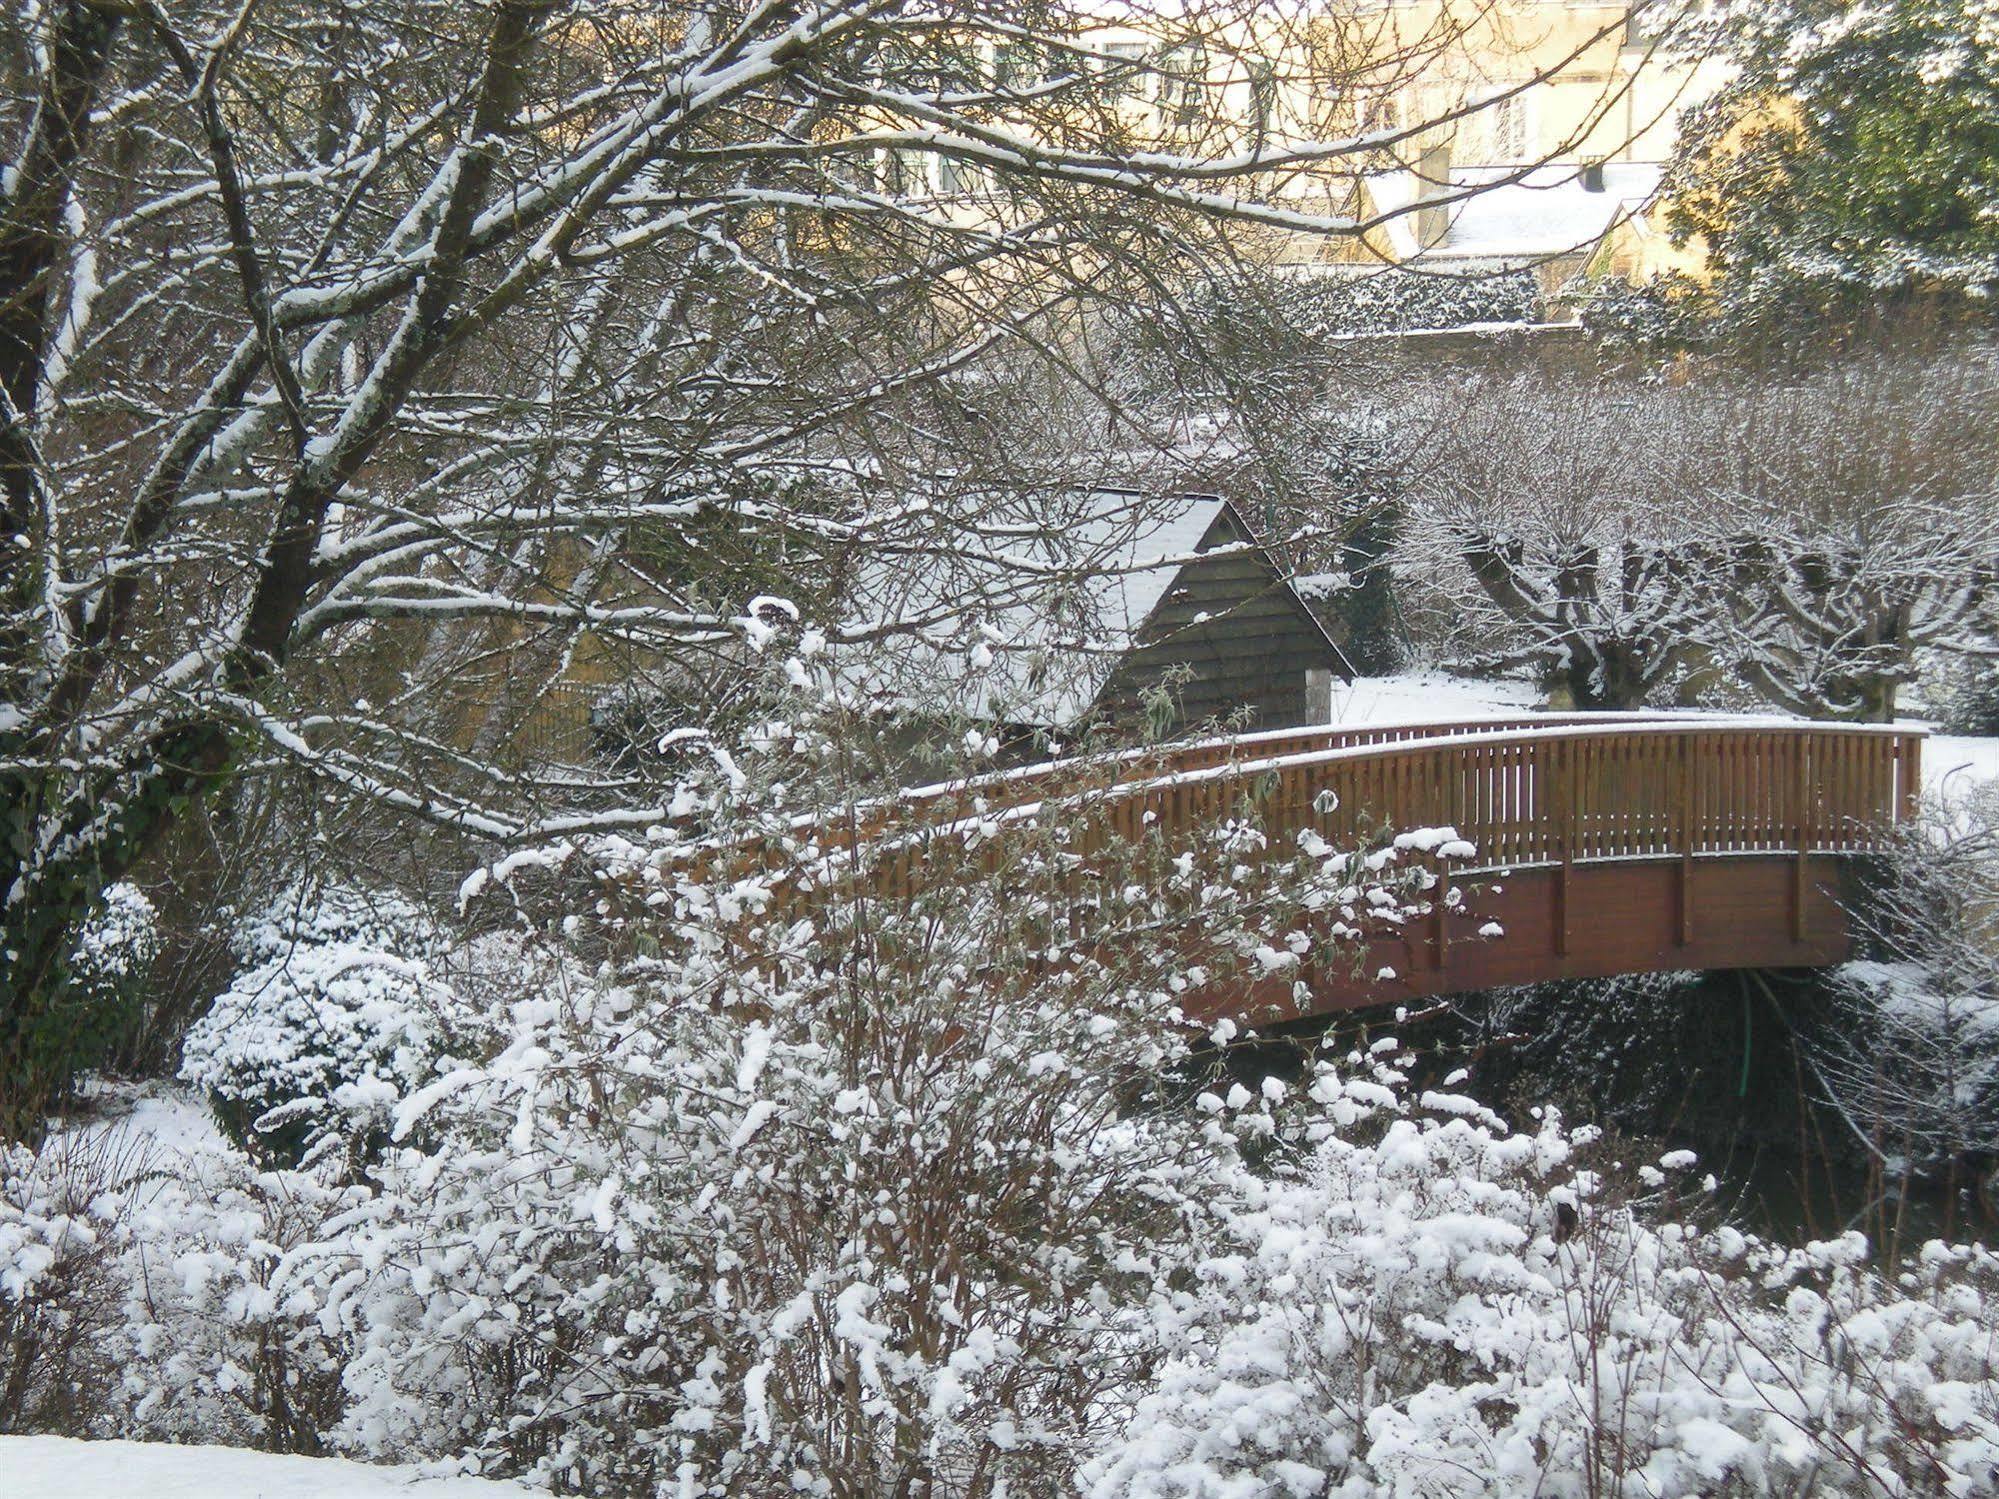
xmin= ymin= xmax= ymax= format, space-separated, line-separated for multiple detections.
xmin=1661 ymin=355 xmax=1999 ymax=722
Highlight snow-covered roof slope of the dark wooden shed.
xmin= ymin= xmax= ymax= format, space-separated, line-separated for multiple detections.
xmin=830 ymin=490 xmax=1227 ymax=726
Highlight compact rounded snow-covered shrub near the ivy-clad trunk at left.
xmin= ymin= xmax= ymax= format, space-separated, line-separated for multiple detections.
xmin=180 ymin=887 xmax=460 ymax=1163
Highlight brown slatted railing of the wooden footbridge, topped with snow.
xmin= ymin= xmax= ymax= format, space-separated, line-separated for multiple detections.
xmin=775 ymin=714 xmax=1923 ymax=895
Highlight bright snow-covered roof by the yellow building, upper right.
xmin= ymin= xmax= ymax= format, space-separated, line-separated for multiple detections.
xmin=1417 ymin=162 xmax=1659 ymax=264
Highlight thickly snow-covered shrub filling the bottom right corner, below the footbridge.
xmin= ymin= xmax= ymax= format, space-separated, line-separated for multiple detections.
xmin=1083 ymin=1043 xmax=1999 ymax=1499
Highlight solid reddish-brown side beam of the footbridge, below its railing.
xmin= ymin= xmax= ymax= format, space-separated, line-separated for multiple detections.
xmin=1187 ymin=853 xmax=1859 ymax=1025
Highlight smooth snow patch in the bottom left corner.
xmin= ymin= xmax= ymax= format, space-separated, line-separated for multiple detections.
xmin=0 ymin=1437 xmax=528 ymax=1499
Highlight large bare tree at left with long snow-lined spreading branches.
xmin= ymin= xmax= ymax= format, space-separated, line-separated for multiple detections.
xmin=0 ymin=0 xmax=1679 ymax=1121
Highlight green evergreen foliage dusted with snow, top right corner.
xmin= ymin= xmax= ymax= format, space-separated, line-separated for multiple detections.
xmin=1639 ymin=0 xmax=1999 ymax=340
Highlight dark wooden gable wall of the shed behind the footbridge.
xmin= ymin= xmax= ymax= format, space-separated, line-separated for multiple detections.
xmin=1097 ymin=510 xmax=1345 ymax=730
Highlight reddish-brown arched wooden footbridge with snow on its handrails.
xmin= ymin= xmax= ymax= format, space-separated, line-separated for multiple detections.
xmin=743 ymin=714 xmax=1923 ymax=1019
